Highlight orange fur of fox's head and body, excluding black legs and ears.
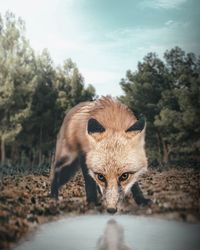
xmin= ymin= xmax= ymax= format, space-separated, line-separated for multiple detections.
xmin=52 ymin=97 xmax=147 ymax=207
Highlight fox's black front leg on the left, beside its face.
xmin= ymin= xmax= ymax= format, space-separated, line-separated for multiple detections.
xmin=79 ymin=154 xmax=97 ymax=204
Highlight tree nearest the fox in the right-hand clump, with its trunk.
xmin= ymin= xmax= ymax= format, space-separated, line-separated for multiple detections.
xmin=120 ymin=53 xmax=168 ymax=164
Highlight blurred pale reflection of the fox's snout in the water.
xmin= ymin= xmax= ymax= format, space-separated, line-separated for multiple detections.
xmin=96 ymin=219 xmax=131 ymax=250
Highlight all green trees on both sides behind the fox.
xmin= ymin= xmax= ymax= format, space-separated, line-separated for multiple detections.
xmin=0 ymin=13 xmax=200 ymax=171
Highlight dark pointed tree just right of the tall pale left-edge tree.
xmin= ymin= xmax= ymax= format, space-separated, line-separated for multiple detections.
xmin=18 ymin=50 xmax=57 ymax=164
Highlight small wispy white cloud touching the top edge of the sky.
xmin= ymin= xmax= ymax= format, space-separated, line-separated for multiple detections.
xmin=140 ymin=0 xmax=187 ymax=9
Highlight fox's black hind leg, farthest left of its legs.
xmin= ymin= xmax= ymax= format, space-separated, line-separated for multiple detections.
xmin=51 ymin=157 xmax=79 ymax=199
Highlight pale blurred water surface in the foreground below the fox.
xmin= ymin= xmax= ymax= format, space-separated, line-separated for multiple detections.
xmin=14 ymin=215 xmax=200 ymax=250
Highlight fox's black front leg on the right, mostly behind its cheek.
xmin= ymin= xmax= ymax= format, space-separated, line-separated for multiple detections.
xmin=131 ymin=182 xmax=152 ymax=206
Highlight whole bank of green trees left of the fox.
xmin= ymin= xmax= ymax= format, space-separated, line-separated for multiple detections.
xmin=0 ymin=12 xmax=95 ymax=166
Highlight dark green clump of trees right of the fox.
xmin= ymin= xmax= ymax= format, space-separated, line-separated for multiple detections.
xmin=120 ymin=47 xmax=200 ymax=166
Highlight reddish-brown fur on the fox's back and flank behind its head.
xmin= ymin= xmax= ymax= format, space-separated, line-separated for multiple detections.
xmin=55 ymin=97 xmax=136 ymax=160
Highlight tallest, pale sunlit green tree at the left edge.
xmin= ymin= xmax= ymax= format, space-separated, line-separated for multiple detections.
xmin=0 ymin=12 xmax=35 ymax=163
